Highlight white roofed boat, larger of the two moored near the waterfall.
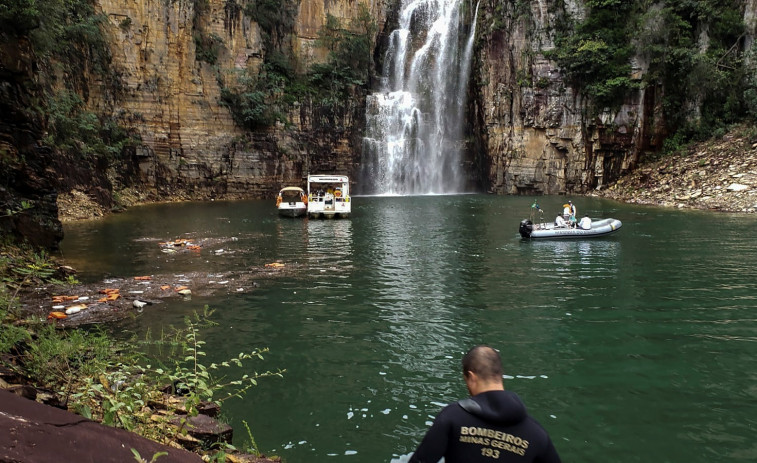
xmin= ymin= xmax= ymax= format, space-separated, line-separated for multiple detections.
xmin=308 ymin=175 xmax=352 ymax=219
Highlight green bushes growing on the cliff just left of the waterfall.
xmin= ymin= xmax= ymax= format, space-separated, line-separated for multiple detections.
xmin=221 ymin=0 xmax=376 ymax=130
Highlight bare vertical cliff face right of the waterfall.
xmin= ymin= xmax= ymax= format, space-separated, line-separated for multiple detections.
xmin=472 ymin=0 xmax=656 ymax=194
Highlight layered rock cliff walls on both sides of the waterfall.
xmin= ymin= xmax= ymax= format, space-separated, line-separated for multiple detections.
xmin=0 ymin=0 xmax=757 ymax=250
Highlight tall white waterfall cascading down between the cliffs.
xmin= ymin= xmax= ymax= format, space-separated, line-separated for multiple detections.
xmin=361 ymin=0 xmax=478 ymax=195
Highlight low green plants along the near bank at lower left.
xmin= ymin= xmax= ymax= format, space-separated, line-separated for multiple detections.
xmin=0 ymin=246 xmax=283 ymax=461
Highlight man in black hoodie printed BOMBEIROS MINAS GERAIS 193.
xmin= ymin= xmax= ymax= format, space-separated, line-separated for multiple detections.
xmin=410 ymin=346 xmax=560 ymax=463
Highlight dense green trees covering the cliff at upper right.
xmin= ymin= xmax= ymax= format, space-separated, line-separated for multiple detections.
xmin=545 ymin=0 xmax=757 ymax=149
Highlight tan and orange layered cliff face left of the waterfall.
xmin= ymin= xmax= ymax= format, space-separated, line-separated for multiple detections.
xmin=92 ymin=0 xmax=384 ymax=198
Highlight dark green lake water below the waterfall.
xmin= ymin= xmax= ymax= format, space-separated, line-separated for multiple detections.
xmin=62 ymin=195 xmax=757 ymax=463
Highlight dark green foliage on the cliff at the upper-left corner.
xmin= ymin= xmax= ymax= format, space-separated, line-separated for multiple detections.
xmin=0 ymin=0 xmax=135 ymax=162
